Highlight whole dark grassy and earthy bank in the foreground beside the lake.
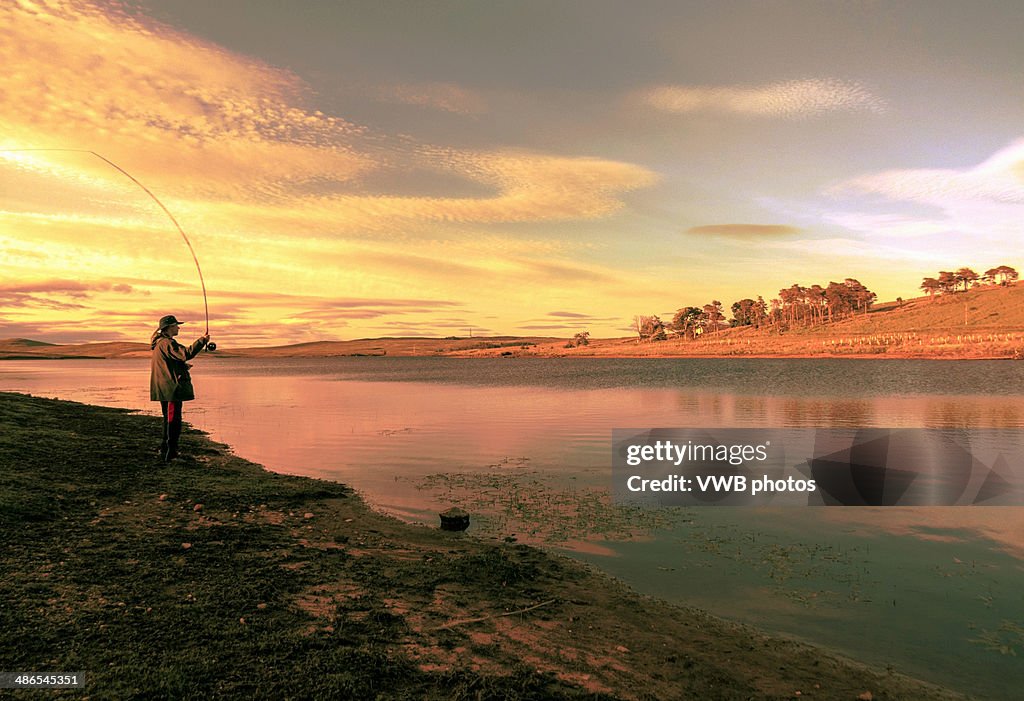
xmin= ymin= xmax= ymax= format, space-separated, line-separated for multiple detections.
xmin=0 ymin=393 xmax=962 ymax=701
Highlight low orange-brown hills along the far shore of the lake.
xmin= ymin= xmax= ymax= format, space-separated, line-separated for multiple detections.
xmin=0 ymin=282 xmax=1024 ymax=359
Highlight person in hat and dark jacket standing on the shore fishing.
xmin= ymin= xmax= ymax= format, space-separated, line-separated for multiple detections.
xmin=150 ymin=314 xmax=210 ymax=463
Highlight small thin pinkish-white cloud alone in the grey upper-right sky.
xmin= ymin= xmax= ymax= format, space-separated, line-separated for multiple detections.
xmin=639 ymin=78 xmax=887 ymax=118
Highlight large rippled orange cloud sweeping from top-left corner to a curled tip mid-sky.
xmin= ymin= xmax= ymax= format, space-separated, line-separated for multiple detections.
xmin=0 ymin=2 xmax=653 ymax=223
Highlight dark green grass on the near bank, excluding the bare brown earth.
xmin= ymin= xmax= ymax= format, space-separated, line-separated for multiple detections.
xmin=0 ymin=394 xmax=607 ymax=699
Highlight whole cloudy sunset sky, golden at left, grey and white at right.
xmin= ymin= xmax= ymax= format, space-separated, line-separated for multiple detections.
xmin=0 ymin=0 xmax=1024 ymax=347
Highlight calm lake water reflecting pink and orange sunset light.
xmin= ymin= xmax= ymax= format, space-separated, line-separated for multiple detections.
xmin=0 ymin=354 xmax=1024 ymax=699
